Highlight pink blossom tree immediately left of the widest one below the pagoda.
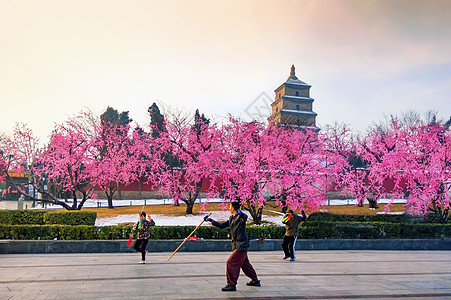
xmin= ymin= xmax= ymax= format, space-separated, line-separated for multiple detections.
xmin=152 ymin=111 xmax=219 ymax=214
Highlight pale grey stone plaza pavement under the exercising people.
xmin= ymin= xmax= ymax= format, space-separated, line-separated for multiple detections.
xmin=0 ymin=251 xmax=451 ymax=300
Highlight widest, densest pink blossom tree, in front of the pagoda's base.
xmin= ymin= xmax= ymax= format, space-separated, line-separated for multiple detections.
xmin=217 ymin=118 xmax=338 ymax=224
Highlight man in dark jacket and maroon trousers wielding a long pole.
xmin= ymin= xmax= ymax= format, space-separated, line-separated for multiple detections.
xmin=204 ymin=202 xmax=261 ymax=292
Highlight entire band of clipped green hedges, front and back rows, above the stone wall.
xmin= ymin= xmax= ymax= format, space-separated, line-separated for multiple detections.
xmin=0 ymin=210 xmax=451 ymax=240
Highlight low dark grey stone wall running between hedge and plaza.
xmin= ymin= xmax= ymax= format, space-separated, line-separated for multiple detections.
xmin=0 ymin=239 xmax=451 ymax=254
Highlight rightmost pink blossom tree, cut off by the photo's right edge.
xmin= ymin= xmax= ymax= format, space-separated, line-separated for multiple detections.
xmin=385 ymin=121 xmax=451 ymax=222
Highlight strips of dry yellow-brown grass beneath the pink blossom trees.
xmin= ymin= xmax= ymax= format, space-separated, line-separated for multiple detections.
xmin=76 ymin=203 xmax=405 ymax=218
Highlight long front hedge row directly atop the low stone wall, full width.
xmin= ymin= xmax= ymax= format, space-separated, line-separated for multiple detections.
xmin=0 ymin=222 xmax=451 ymax=240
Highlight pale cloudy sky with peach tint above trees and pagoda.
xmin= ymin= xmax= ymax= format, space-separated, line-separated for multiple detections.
xmin=0 ymin=0 xmax=451 ymax=141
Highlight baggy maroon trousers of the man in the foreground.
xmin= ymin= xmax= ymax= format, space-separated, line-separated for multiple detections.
xmin=226 ymin=250 xmax=258 ymax=285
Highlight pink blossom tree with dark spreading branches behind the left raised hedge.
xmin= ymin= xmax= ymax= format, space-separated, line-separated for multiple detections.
xmin=32 ymin=112 xmax=98 ymax=210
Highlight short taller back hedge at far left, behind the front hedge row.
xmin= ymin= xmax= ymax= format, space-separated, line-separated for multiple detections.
xmin=0 ymin=209 xmax=97 ymax=226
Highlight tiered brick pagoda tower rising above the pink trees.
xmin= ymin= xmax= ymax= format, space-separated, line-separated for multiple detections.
xmin=271 ymin=65 xmax=318 ymax=130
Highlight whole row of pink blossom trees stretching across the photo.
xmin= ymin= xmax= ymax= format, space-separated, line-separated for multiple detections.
xmin=0 ymin=103 xmax=451 ymax=224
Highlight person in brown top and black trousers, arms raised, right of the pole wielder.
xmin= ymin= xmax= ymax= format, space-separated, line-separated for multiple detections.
xmin=282 ymin=209 xmax=307 ymax=261
